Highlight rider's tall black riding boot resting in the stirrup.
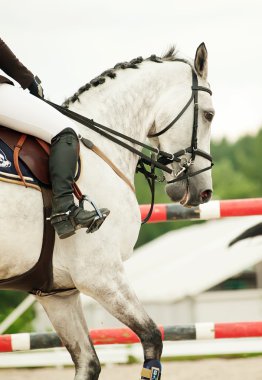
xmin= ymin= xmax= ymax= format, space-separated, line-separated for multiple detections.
xmin=49 ymin=128 xmax=109 ymax=239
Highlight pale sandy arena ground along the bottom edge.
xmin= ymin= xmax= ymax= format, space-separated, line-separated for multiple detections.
xmin=0 ymin=357 xmax=262 ymax=380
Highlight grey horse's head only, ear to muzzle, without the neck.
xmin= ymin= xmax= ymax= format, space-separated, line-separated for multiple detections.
xmin=149 ymin=43 xmax=214 ymax=206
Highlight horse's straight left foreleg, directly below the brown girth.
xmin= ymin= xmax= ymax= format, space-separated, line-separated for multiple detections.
xmin=37 ymin=292 xmax=101 ymax=380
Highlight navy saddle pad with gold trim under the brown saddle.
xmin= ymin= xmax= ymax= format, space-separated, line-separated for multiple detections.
xmin=0 ymin=139 xmax=40 ymax=190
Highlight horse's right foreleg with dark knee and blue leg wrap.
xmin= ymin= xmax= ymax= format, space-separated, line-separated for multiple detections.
xmin=77 ymin=265 xmax=163 ymax=380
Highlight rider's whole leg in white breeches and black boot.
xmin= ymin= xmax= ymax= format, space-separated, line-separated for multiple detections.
xmin=0 ymin=84 xmax=109 ymax=238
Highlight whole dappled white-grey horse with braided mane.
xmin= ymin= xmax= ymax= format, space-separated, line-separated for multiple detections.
xmin=0 ymin=44 xmax=214 ymax=380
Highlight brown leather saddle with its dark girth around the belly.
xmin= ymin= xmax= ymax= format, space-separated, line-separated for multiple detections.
xmin=0 ymin=126 xmax=64 ymax=295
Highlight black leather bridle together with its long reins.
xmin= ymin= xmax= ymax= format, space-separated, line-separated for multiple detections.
xmin=45 ymin=59 xmax=213 ymax=223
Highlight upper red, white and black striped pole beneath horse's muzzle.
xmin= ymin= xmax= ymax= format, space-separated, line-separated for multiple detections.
xmin=140 ymin=198 xmax=262 ymax=223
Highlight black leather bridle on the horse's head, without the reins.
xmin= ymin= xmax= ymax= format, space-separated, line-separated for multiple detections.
xmin=148 ymin=59 xmax=213 ymax=183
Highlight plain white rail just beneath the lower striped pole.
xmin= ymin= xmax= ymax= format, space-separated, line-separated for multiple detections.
xmin=0 ymin=338 xmax=262 ymax=368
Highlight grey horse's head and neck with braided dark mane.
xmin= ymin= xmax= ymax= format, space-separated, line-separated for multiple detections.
xmin=64 ymin=43 xmax=214 ymax=206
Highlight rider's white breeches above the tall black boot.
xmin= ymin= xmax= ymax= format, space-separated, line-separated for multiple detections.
xmin=0 ymin=83 xmax=75 ymax=143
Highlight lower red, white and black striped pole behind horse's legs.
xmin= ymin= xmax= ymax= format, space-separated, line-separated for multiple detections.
xmin=0 ymin=322 xmax=262 ymax=352
